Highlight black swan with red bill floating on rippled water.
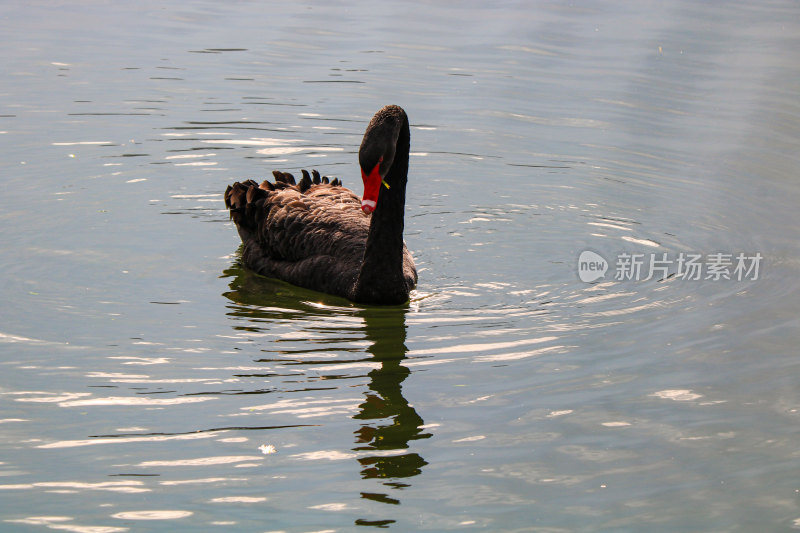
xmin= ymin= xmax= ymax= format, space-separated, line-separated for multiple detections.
xmin=225 ymin=105 xmax=417 ymax=305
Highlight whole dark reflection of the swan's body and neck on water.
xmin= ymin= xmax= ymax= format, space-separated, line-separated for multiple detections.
xmin=223 ymin=265 xmax=431 ymax=504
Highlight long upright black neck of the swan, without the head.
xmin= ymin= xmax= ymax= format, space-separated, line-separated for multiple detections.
xmin=355 ymin=117 xmax=410 ymax=303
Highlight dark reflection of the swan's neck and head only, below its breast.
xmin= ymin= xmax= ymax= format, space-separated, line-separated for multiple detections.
xmin=354 ymin=308 xmax=431 ymax=484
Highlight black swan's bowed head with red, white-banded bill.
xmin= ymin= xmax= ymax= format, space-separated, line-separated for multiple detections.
xmin=358 ymin=106 xmax=405 ymax=214
